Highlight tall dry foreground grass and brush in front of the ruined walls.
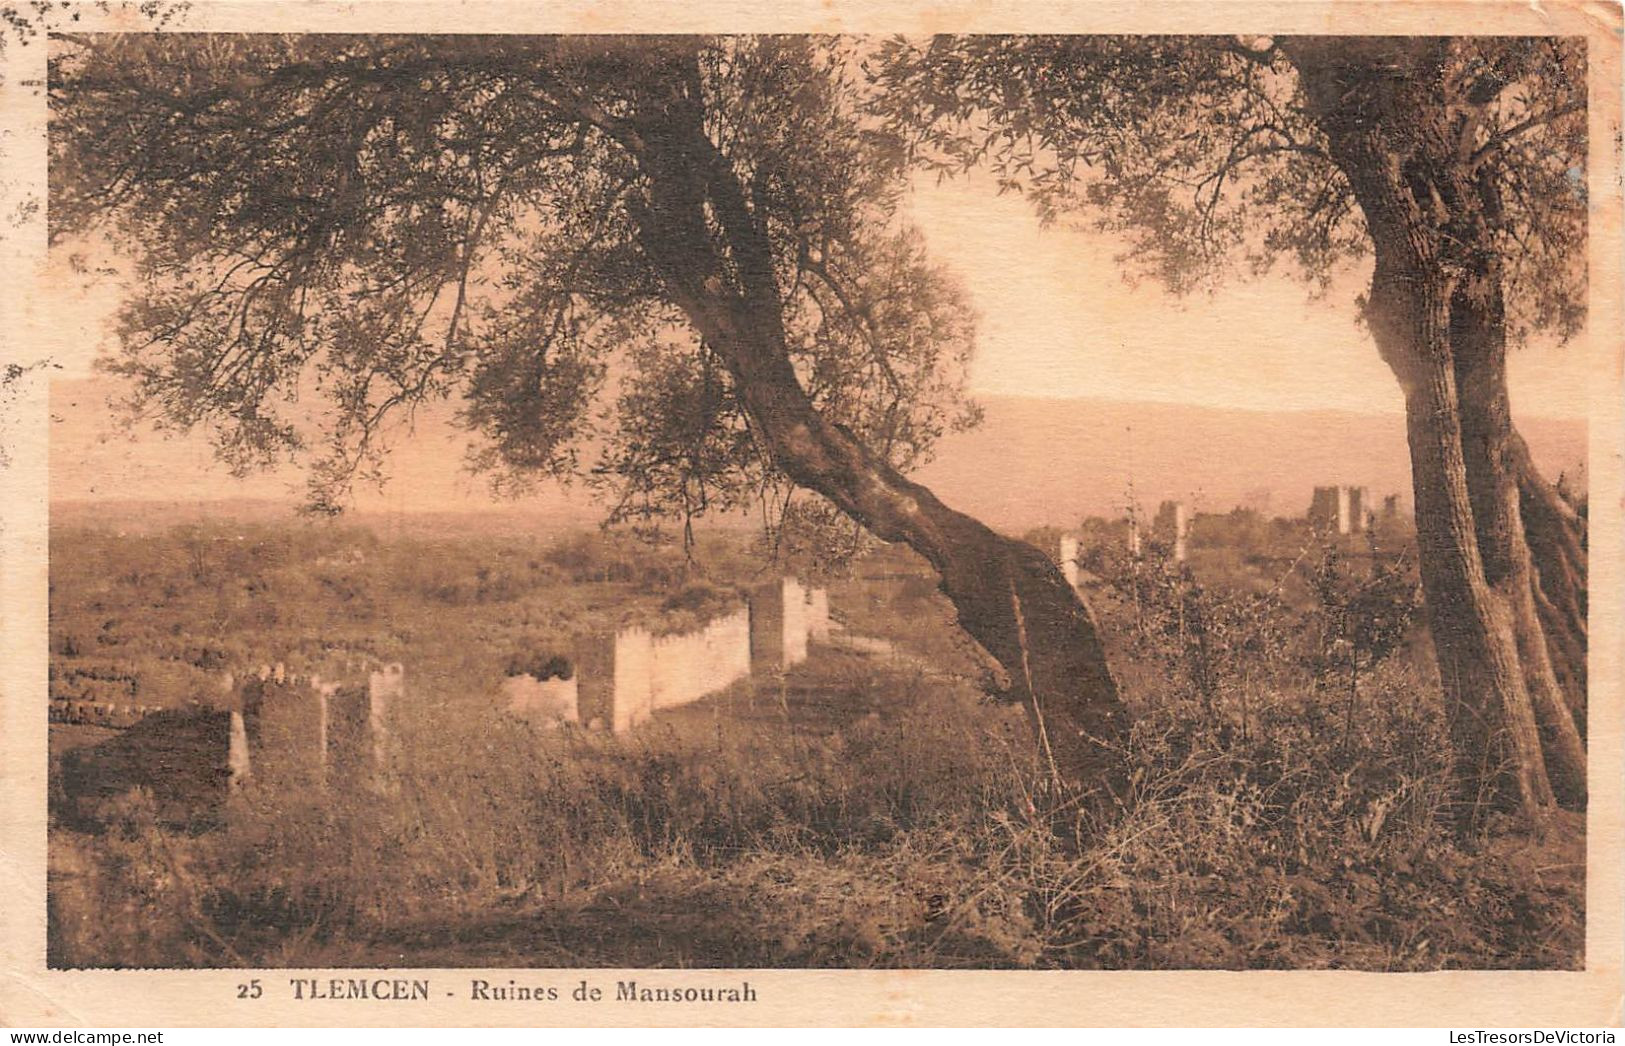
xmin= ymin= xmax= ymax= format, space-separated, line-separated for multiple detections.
xmin=49 ymin=519 xmax=1584 ymax=970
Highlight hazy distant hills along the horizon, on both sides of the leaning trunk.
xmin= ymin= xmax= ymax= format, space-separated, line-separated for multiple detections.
xmin=50 ymin=378 xmax=1586 ymax=533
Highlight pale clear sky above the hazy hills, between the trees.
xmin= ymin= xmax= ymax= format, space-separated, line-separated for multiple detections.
xmin=55 ymin=167 xmax=1586 ymax=417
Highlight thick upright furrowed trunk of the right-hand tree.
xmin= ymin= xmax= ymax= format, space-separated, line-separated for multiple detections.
xmin=1282 ymin=39 xmax=1584 ymax=823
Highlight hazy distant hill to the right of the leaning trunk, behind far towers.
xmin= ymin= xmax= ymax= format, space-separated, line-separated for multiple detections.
xmin=918 ymin=396 xmax=1586 ymax=533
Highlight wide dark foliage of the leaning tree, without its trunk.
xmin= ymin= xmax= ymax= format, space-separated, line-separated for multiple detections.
xmin=50 ymin=34 xmax=975 ymax=520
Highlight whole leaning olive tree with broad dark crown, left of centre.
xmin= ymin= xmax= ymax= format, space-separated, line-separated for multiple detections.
xmin=50 ymin=34 xmax=1125 ymax=794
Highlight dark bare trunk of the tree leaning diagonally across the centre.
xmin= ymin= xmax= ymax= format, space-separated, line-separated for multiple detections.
xmin=632 ymin=89 xmax=1126 ymax=807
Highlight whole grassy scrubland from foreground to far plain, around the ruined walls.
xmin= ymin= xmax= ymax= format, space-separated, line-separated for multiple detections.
xmin=49 ymin=517 xmax=1584 ymax=970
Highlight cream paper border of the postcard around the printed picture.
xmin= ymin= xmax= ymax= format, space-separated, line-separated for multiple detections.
xmin=0 ymin=0 xmax=1625 ymax=1027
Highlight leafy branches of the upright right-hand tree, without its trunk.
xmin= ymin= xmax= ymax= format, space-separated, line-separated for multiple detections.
xmin=869 ymin=36 xmax=1588 ymax=339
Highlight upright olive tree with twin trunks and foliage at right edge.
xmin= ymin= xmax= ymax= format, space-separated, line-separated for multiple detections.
xmin=869 ymin=36 xmax=1588 ymax=815
